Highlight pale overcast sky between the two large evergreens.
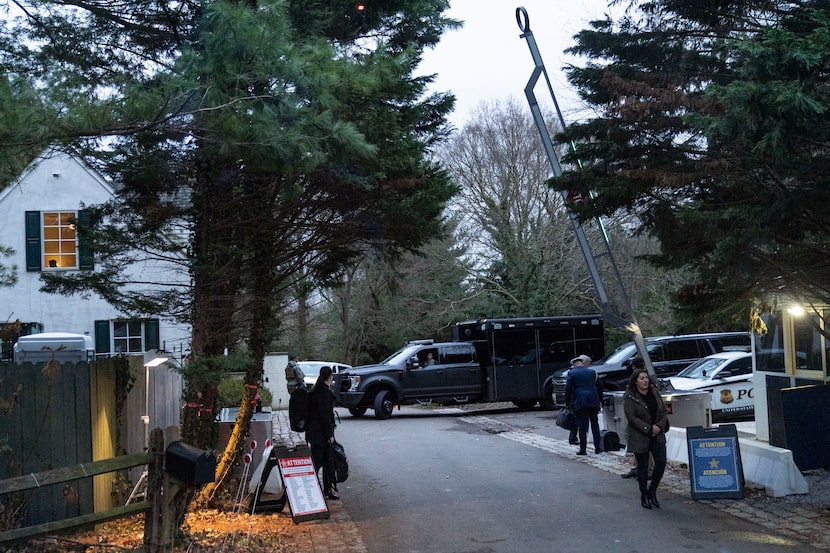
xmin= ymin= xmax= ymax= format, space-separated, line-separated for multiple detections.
xmin=418 ymin=0 xmax=608 ymax=128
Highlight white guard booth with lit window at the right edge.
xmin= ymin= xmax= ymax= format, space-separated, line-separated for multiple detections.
xmin=752 ymin=302 xmax=830 ymax=471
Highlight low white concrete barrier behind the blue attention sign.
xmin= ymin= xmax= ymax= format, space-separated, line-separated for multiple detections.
xmin=666 ymin=428 xmax=810 ymax=497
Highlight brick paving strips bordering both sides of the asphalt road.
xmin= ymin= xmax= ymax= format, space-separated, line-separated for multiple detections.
xmin=274 ymin=408 xmax=830 ymax=553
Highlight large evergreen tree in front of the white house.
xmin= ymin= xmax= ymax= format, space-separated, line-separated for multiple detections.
xmin=0 ymin=0 xmax=456 ymax=504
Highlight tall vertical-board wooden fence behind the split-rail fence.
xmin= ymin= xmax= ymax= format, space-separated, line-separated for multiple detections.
xmin=0 ymin=356 xmax=182 ymax=528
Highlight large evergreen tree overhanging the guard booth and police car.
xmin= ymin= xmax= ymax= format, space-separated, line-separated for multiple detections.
xmin=553 ymin=0 xmax=830 ymax=327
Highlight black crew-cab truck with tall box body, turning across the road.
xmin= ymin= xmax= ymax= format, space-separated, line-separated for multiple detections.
xmin=332 ymin=315 xmax=604 ymax=419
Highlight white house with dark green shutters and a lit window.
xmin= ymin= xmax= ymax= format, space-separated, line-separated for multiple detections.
xmin=0 ymin=150 xmax=191 ymax=360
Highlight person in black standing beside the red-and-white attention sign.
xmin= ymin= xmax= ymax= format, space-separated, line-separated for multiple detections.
xmin=305 ymin=366 xmax=340 ymax=499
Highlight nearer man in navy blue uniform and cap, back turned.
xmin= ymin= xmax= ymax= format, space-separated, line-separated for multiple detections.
xmin=565 ymin=357 xmax=602 ymax=455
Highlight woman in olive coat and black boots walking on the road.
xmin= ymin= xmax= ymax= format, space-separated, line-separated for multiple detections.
xmin=623 ymin=369 xmax=668 ymax=509
